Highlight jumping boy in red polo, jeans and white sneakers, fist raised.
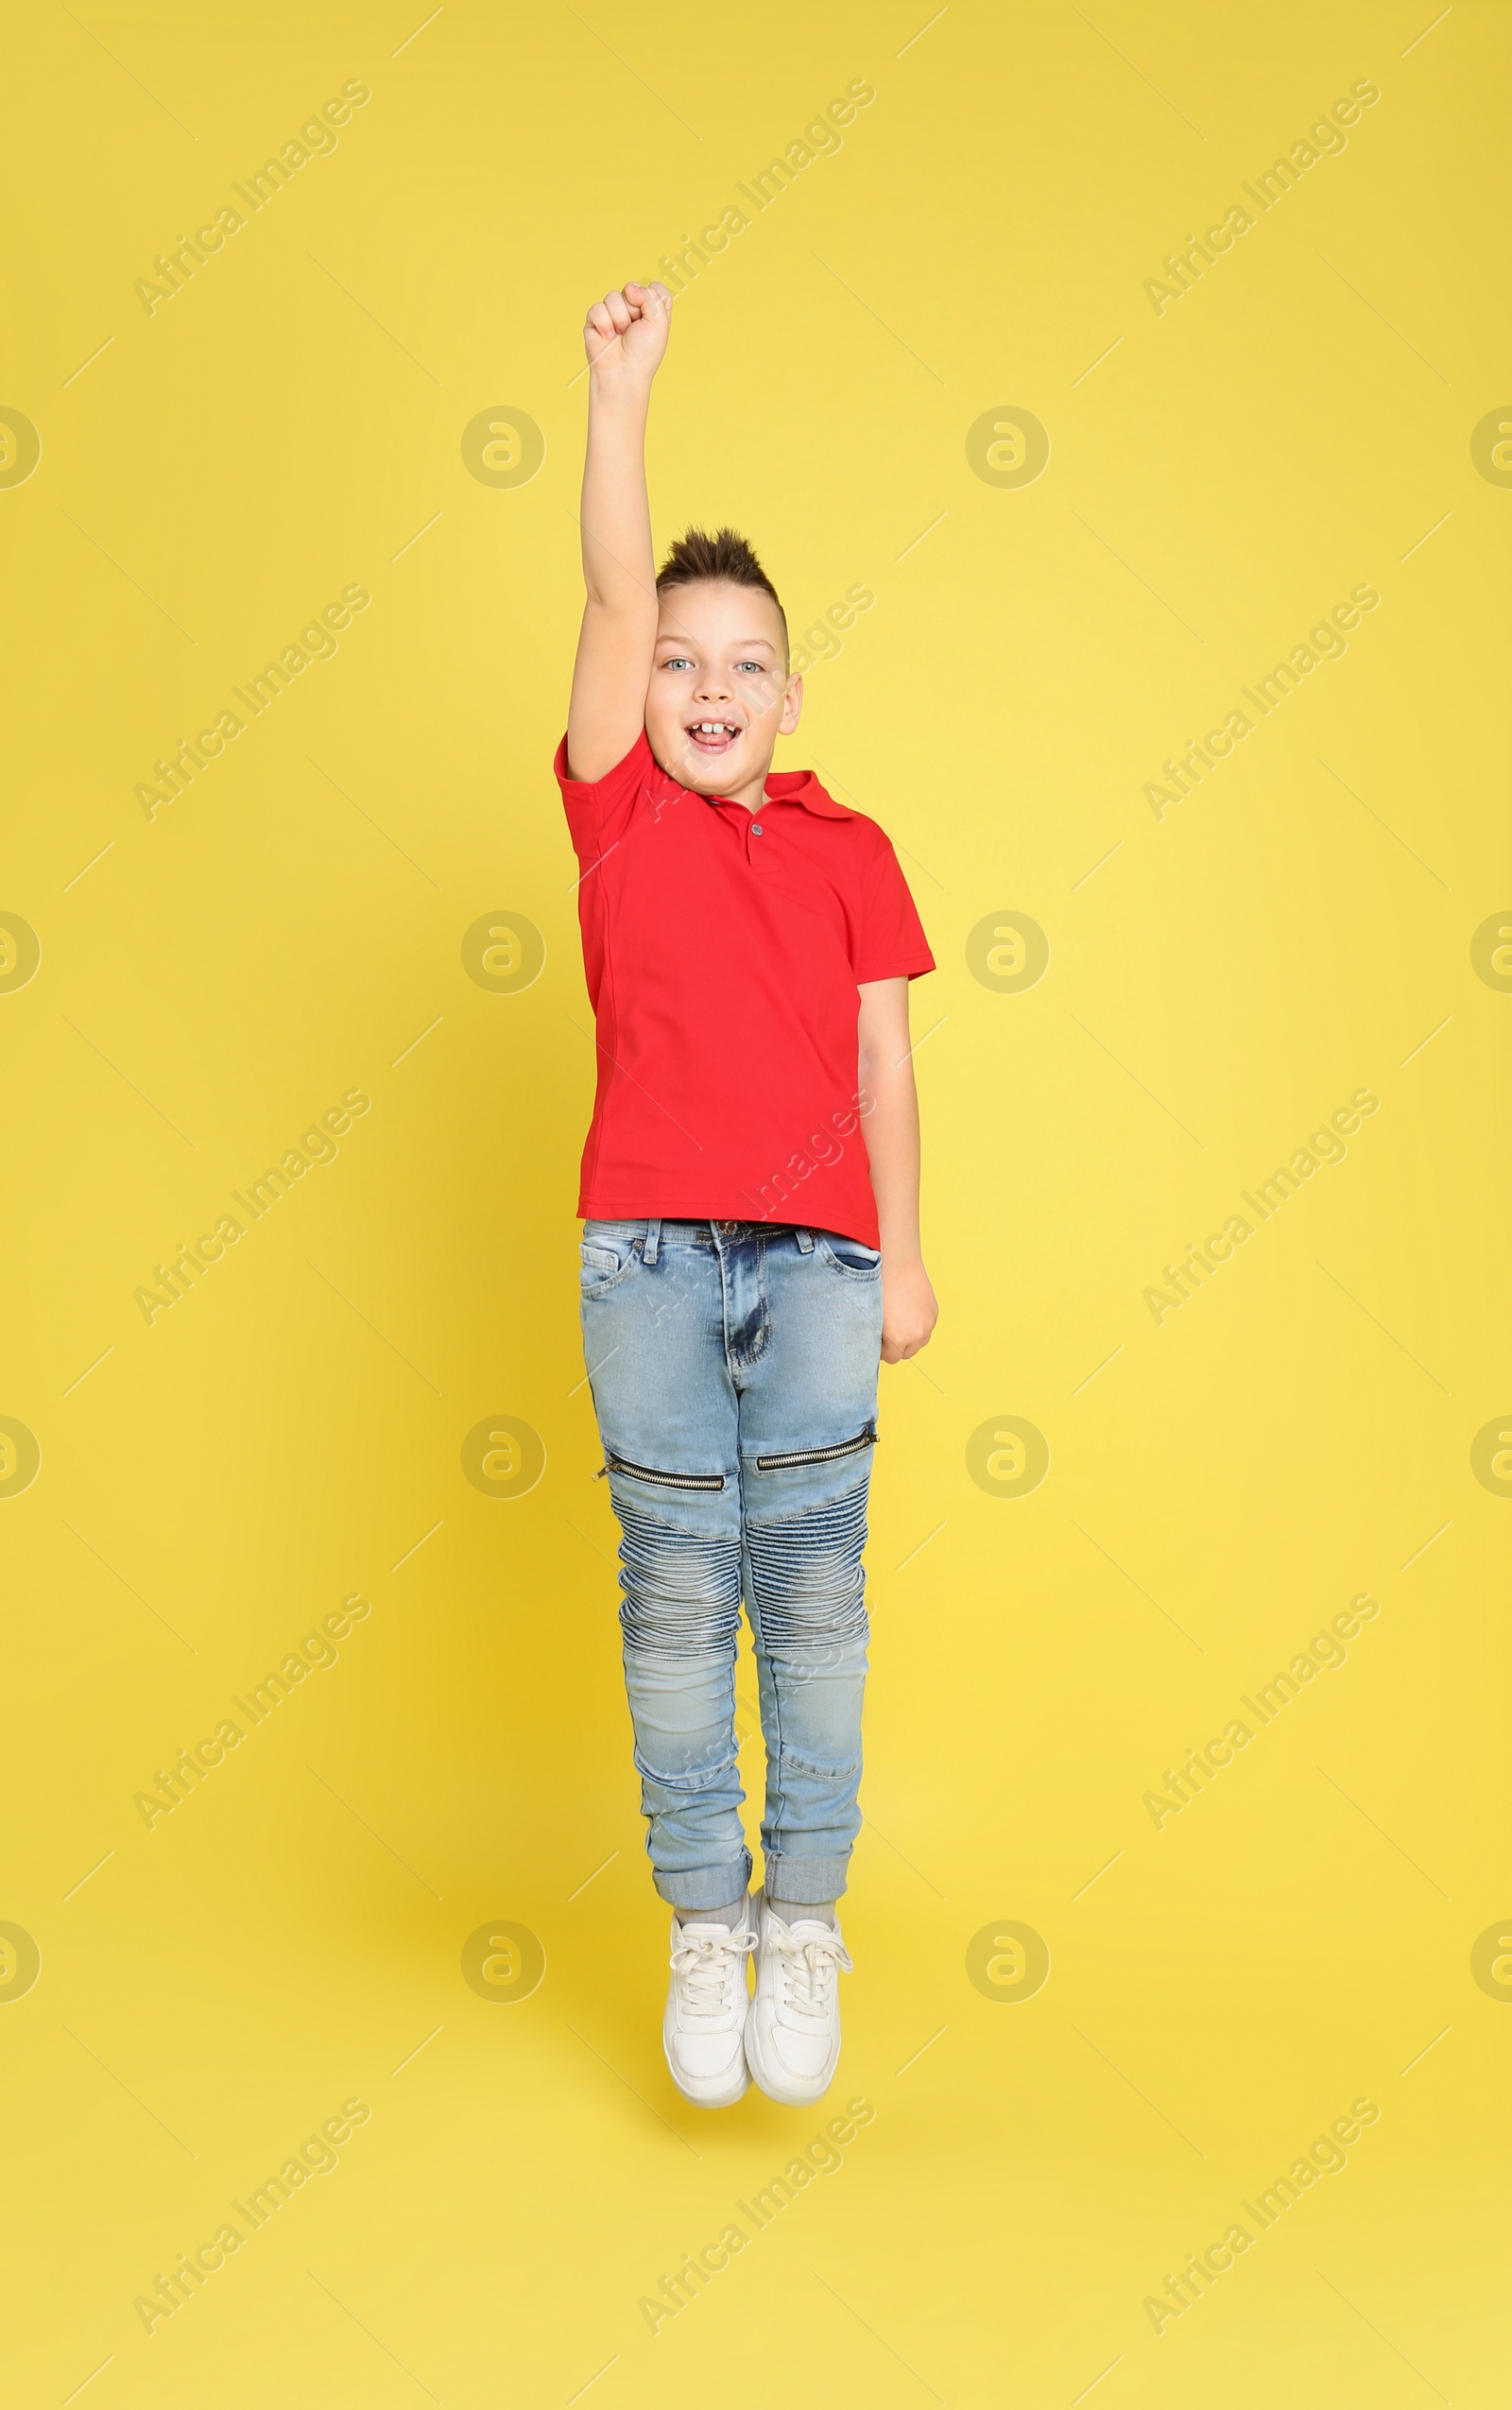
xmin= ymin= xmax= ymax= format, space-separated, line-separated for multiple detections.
xmin=557 ymin=284 xmax=936 ymax=2109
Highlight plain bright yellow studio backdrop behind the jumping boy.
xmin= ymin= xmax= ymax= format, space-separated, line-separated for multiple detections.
xmin=0 ymin=0 xmax=1512 ymax=2410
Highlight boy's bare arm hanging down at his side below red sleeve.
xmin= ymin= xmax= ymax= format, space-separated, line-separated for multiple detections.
xmin=856 ymin=978 xmax=938 ymax=1364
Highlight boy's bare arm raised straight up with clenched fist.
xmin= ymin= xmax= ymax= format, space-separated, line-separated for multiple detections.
xmin=567 ymin=284 xmax=673 ymax=779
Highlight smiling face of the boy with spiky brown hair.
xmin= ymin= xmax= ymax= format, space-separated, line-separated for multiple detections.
xmin=646 ymin=581 xmax=803 ymax=798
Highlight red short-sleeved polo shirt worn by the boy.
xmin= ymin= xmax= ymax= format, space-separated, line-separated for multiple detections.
xmin=557 ymin=731 xmax=936 ymax=1246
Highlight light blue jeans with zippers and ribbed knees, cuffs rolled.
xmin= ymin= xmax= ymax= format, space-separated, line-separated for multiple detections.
xmin=581 ymin=1222 xmax=883 ymax=1911
